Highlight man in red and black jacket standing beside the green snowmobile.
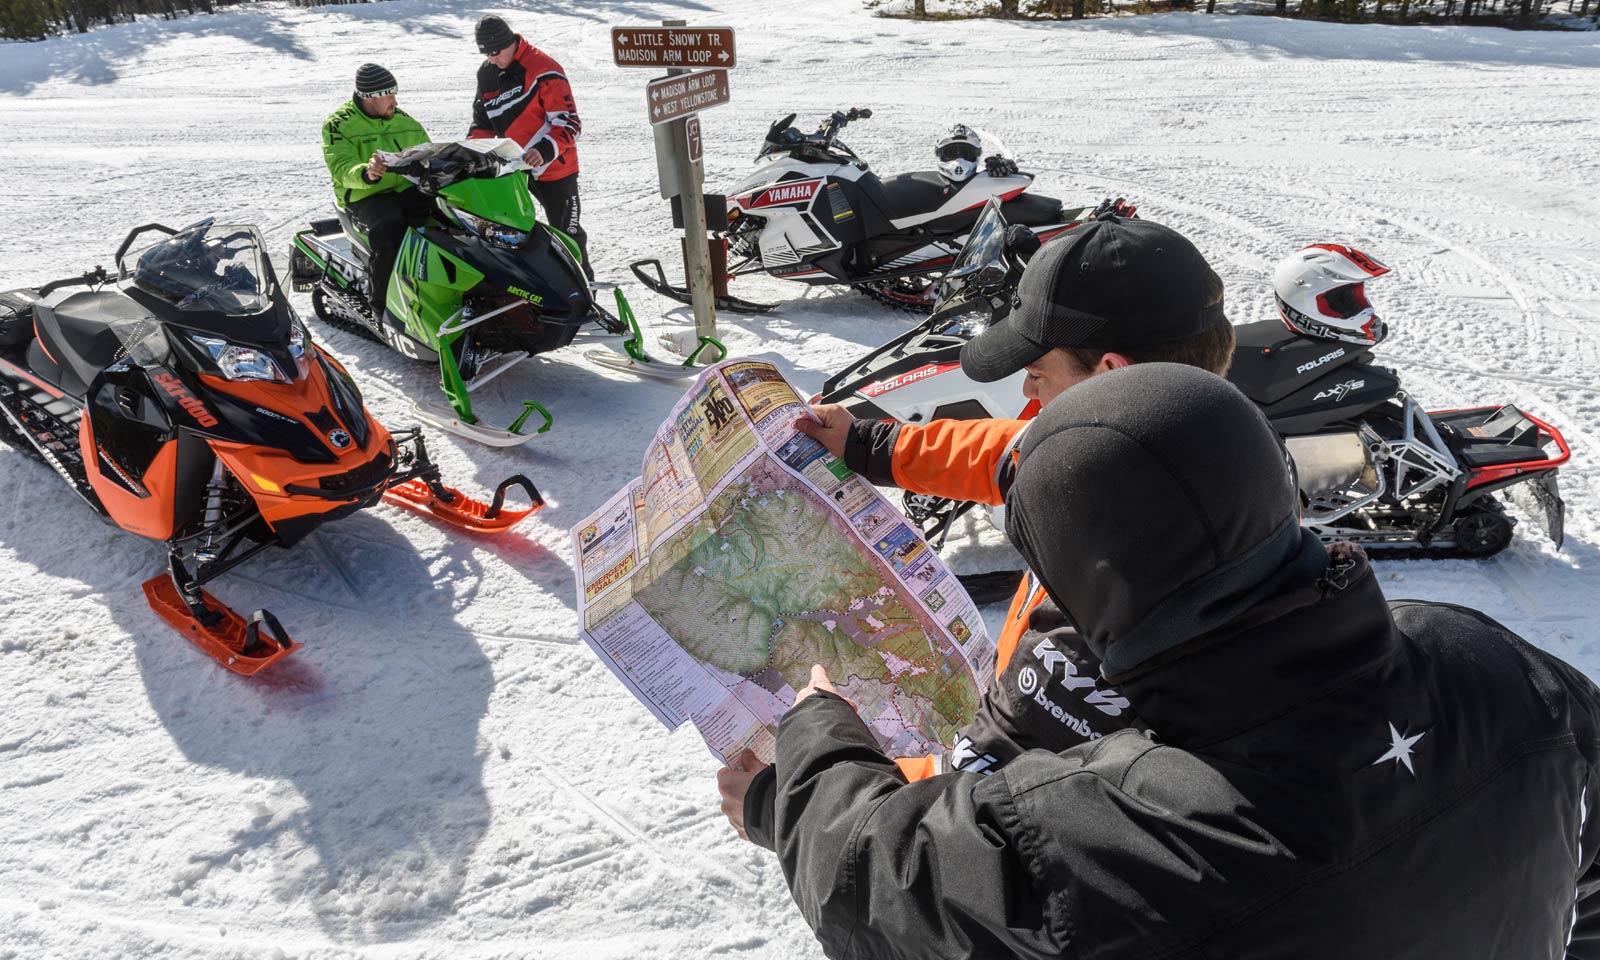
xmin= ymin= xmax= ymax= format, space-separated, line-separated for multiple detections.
xmin=467 ymin=16 xmax=595 ymax=280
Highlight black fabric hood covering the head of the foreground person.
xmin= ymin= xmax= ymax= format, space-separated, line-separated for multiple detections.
xmin=1006 ymin=363 xmax=1328 ymax=677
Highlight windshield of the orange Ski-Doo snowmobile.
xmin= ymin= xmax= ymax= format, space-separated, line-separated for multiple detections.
xmin=120 ymin=221 xmax=272 ymax=315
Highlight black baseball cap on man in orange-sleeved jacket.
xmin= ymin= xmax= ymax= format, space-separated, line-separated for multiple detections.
xmin=962 ymin=216 xmax=1227 ymax=382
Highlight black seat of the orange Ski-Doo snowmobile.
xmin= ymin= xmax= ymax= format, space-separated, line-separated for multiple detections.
xmin=29 ymin=290 xmax=150 ymax=397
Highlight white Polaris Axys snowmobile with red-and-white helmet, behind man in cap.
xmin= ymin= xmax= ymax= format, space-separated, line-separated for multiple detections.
xmin=813 ymin=203 xmax=1571 ymax=576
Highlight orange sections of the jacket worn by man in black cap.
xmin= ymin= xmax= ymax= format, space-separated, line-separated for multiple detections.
xmin=891 ymin=419 xmax=1045 ymax=781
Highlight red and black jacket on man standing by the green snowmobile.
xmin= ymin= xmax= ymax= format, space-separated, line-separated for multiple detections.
xmin=467 ymin=35 xmax=582 ymax=181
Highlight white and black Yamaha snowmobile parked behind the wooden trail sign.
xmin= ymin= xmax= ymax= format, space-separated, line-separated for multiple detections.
xmin=632 ymin=109 xmax=1088 ymax=314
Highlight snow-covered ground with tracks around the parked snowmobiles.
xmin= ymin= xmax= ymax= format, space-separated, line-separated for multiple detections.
xmin=0 ymin=0 xmax=1600 ymax=960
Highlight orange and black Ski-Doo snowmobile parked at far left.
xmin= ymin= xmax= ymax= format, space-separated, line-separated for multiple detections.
xmin=0 ymin=221 xmax=544 ymax=674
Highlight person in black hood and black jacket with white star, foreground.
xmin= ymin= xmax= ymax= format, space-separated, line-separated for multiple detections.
xmin=758 ymin=363 xmax=1600 ymax=960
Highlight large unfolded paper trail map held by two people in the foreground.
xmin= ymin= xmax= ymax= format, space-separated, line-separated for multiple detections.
xmin=573 ymin=360 xmax=994 ymax=760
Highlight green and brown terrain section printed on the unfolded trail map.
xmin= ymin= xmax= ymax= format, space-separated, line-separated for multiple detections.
xmin=634 ymin=456 xmax=981 ymax=755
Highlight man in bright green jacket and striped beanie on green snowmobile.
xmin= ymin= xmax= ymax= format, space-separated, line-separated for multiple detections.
xmin=322 ymin=64 xmax=434 ymax=317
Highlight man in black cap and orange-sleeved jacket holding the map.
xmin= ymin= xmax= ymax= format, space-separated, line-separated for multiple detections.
xmin=718 ymin=213 xmax=1234 ymax=845
